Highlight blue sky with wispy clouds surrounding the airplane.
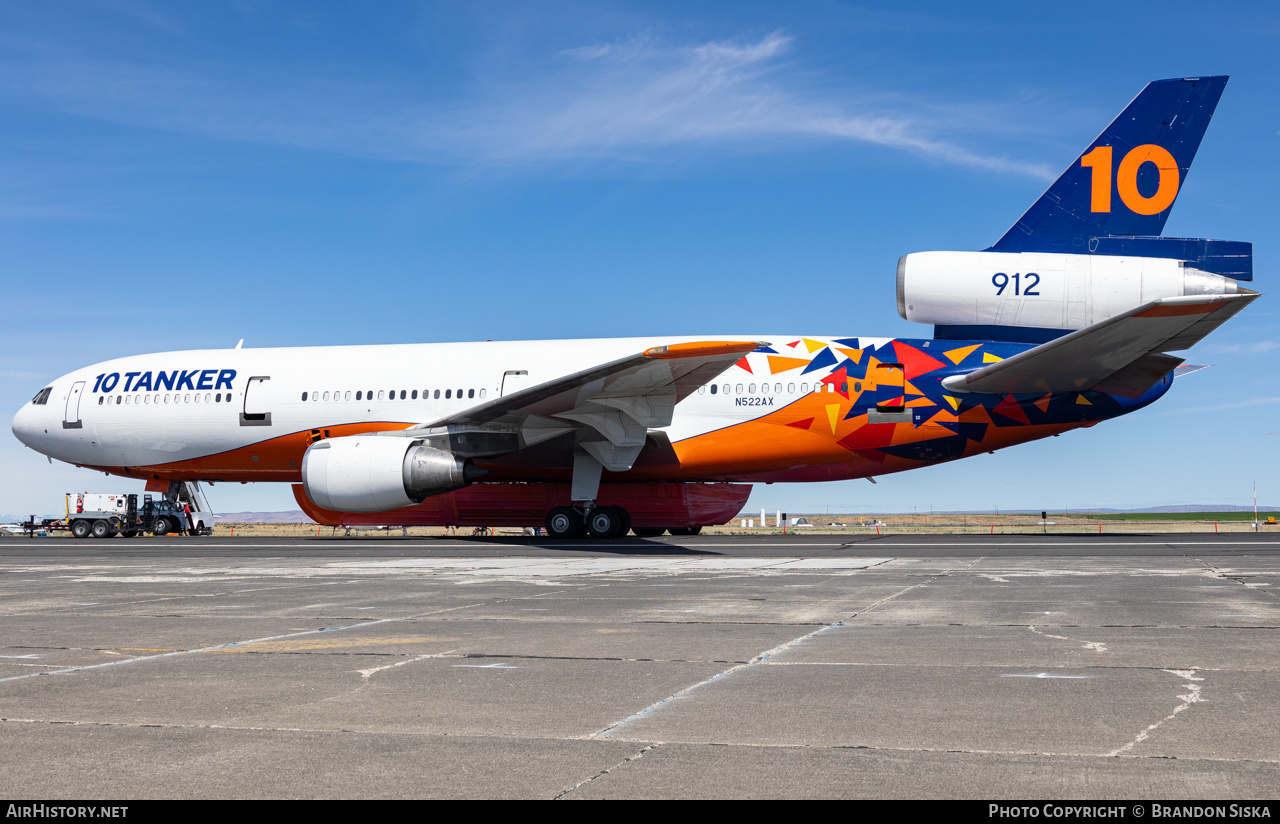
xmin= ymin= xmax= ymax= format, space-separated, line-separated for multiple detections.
xmin=0 ymin=0 xmax=1280 ymax=514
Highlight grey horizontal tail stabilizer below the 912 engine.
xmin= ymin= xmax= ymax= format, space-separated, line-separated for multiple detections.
xmin=942 ymin=289 xmax=1258 ymax=398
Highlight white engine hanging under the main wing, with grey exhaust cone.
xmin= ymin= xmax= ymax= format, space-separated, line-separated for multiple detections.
xmin=302 ymin=435 xmax=485 ymax=512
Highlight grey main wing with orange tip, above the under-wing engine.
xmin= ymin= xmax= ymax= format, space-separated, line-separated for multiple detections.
xmin=398 ymin=340 xmax=768 ymax=471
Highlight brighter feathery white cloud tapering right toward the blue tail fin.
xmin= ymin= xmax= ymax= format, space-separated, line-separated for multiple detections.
xmin=447 ymin=33 xmax=1052 ymax=178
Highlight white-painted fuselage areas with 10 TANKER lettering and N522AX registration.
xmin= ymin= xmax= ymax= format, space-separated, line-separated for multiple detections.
xmin=13 ymin=335 xmax=890 ymax=475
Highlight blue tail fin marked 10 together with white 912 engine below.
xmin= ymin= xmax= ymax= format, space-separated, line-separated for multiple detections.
xmin=897 ymin=77 xmax=1253 ymax=343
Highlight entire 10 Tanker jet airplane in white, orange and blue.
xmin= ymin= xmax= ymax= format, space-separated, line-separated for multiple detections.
xmin=13 ymin=77 xmax=1258 ymax=539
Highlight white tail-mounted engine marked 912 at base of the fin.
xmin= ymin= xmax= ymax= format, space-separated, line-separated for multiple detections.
xmin=897 ymin=252 xmax=1238 ymax=329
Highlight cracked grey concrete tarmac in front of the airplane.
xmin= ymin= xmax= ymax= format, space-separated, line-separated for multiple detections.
xmin=0 ymin=534 xmax=1280 ymax=801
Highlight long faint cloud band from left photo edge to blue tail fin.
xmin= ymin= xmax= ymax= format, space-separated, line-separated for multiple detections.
xmin=0 ymin=33 xmax=1053 ymax=179
